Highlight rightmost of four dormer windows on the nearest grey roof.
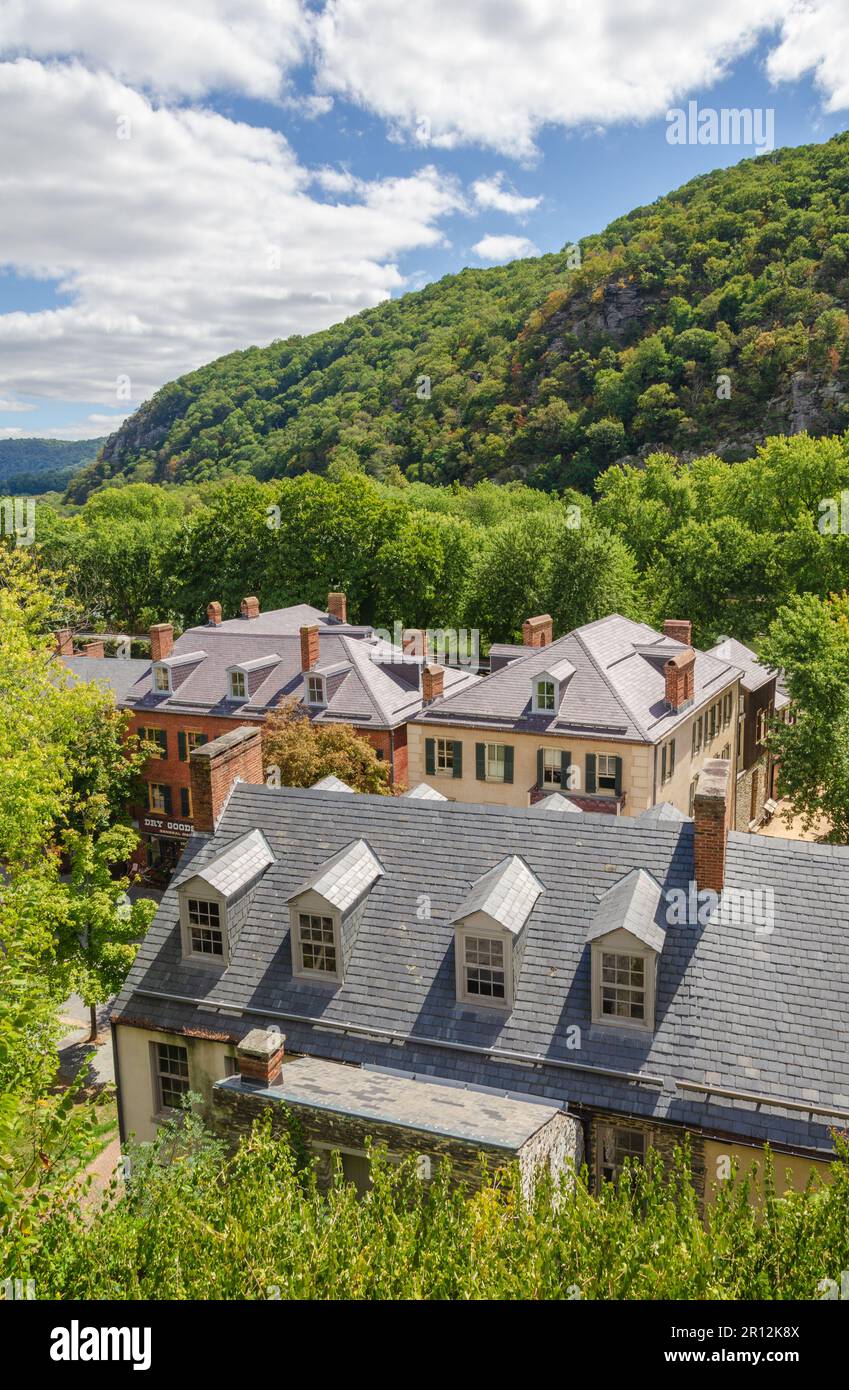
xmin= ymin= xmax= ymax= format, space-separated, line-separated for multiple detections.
xmin=586 ymin=869 xmax=666 ymax=1031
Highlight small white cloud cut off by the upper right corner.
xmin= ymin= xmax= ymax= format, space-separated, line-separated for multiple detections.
xmin=767 ymin=0 xmax=849 ymax=111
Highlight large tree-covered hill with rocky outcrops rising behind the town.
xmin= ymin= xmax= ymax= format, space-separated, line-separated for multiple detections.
xmin=69 ymin=135 xmax=849 ymax=500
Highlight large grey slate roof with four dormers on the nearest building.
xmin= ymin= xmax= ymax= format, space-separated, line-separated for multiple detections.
xmin=115 ymin=783 xmax=849 ymax=1151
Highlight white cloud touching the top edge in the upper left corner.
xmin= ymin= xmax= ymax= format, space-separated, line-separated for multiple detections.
xmin=0 ymin=0 xmax=308 ymax=100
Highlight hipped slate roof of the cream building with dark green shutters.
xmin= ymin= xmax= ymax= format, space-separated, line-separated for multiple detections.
xmin=417 ymin=613 xmax=738 ymax=744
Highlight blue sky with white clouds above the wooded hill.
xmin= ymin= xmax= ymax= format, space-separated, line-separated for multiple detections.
xmin=0 ymin=0 xmax=849 ymax=438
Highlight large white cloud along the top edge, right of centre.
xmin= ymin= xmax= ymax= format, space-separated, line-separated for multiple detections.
xmin=315 ymin=0 xmax=783 ymax=158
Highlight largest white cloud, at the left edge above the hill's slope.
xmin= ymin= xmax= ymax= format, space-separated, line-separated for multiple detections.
xmin=0 ymin=60 xmax=463 ymax=406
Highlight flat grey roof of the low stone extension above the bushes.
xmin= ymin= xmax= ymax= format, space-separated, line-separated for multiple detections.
xmin=215 ymin=1056 xmax=560 ymax=1154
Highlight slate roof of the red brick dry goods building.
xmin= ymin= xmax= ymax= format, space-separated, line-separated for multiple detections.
xmin=68 ymin=625 xmax=479 ymax=728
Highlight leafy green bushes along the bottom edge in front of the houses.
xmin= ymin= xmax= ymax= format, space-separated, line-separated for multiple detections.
xmin=13 ymin=1115 xmax=849 ymax=1300
